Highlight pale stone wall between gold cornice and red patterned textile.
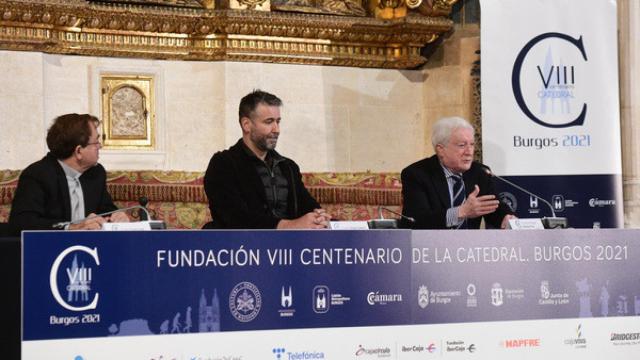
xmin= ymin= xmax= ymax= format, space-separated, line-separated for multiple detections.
xmin=0 ymin=51 xmax=425 ymax=172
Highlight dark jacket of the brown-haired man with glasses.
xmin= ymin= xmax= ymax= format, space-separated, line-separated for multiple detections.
xmin=9 ymin=153 xmax=117 ymax=235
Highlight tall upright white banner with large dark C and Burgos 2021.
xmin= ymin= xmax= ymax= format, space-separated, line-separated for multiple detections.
xmin=481 ymin=0 xmax=623 ymax=227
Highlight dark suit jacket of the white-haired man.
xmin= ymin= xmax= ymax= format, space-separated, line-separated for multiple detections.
xmin=400 ymin=155 xmax=511 ymax=229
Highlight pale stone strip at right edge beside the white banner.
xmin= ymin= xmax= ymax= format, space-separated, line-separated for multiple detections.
xmin=618 ymin=0 xmax=640 ymax=227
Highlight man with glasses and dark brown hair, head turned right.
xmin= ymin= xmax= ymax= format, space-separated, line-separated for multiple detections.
xmin=9 ymin=114 xmax=129 ymax=235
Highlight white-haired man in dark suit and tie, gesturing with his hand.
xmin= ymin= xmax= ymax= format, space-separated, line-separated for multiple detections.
xmin=401 ymin=117 xmax=513 ymax=229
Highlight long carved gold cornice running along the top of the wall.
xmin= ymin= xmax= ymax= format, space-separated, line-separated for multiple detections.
xmin=0 ymin=0 xmax=455 ymax=69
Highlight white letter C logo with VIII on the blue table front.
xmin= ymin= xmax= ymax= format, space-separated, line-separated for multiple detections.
xmin=49 ymin=245 xmax=100 ymax=311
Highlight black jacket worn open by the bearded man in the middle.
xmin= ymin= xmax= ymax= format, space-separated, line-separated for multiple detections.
xmin=204 ymin=139 xmax=320 ymax=229
